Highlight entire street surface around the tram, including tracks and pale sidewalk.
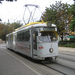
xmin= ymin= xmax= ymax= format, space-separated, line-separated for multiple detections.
xmin=0 ymin=44 xmax=75 ymax=75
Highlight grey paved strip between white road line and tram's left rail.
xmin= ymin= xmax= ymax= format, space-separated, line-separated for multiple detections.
xmin=5 ymin=48 xmax=67 ymax=75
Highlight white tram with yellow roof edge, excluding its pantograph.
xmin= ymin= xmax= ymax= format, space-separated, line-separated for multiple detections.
xmin=6 ymin=21 xmax=58 ymax=60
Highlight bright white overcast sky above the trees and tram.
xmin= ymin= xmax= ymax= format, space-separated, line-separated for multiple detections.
xmin=0 ymin=0 xmax=74 ymax=23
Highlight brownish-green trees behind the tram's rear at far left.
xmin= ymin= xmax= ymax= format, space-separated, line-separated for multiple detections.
xmin=0 ymin=22 xmax=22 ymax=40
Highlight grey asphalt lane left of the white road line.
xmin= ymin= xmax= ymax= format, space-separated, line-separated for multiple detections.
xmin=0 ymin=45 xmax=40 ymax=75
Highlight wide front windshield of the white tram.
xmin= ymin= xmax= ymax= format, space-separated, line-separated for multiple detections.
xmin=39 ymin=31 xmax=57 ymax=42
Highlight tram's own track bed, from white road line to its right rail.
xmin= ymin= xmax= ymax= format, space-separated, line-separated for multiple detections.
xmin=5 ymin=47 xmax=75 ymax=75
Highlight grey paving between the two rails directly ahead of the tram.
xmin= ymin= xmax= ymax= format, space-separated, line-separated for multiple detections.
xmin=43 ymin=59 xmax=75 ymax=75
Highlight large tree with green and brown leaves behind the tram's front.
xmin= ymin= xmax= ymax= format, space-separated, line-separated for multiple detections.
xmin=42 ymin=1 xmax=71 ymax=40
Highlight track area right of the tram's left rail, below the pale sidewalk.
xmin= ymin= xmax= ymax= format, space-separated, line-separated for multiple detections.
xmin=43 ymin=53 xmax=75 ymax=75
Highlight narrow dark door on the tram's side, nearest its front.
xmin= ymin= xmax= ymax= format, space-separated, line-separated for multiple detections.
xmin=32 ymin=31 xmax=38 ymax=58
